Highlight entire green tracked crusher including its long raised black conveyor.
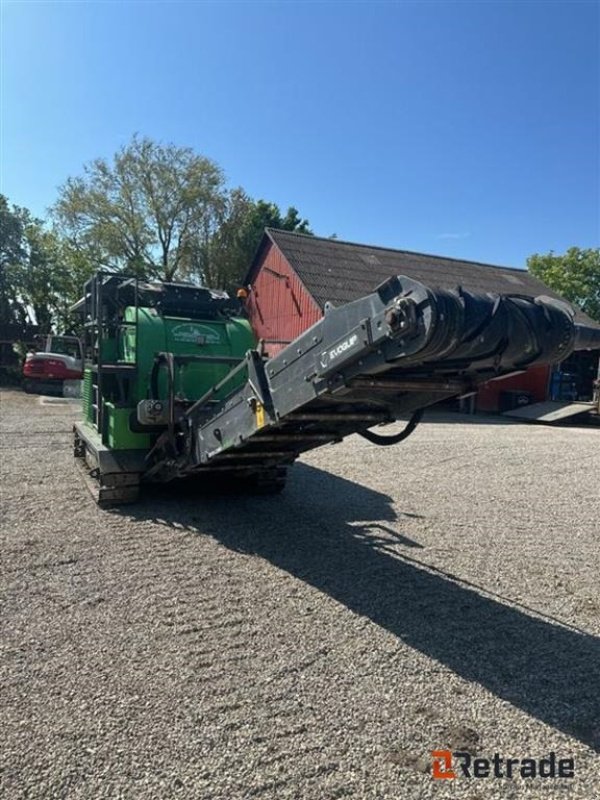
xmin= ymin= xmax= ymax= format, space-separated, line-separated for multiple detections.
xmin=74 ymin=272 xmax=600 ymax=504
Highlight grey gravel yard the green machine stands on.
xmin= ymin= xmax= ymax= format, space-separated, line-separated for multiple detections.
xmin=0 ymin=384 xmax=600 ymax=800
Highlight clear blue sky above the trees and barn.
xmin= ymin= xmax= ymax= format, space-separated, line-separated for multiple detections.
xmin=1 ymin=0 xmax=600 ymax=266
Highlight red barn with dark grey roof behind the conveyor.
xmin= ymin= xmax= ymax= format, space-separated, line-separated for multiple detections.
xmin=246 ymin=228 xmax=598 ymax=411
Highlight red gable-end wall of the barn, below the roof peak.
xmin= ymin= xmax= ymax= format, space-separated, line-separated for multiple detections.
xmin=246 ymin=243 xmax=322 ymax=355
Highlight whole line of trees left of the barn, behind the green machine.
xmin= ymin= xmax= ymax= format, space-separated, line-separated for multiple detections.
xmin=0 ymin=136 xmax=311 ymax=332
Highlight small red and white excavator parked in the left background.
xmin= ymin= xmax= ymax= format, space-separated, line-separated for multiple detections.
xmin=23 ymin=335 xmax=83 ymax=394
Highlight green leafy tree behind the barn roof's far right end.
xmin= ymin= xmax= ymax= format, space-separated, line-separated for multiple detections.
xmin=527 ymin=247 xmax=600 ymax=322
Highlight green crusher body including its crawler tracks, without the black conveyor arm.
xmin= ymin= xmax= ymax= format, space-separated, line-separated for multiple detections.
xmin=75 ymin=272 xmax=256 ymax=504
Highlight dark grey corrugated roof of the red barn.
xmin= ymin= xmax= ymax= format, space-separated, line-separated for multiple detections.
xmin=247 ymin=228 xmax=597 ymax=325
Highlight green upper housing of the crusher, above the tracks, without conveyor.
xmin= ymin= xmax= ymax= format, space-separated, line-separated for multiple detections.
xmin=78 ymin=278 xmax=256 ymax=450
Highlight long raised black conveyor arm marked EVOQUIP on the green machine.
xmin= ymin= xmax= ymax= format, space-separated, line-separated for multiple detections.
xmin=146 ymin=276 xmax=600 ymax=480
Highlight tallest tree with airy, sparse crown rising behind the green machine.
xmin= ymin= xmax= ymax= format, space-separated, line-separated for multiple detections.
xmin=53 ymin=136 xmax=226 ymax=281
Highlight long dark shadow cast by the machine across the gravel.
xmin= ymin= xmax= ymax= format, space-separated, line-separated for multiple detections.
xmin=120 ymin=464 xmax=600 ymax=751
